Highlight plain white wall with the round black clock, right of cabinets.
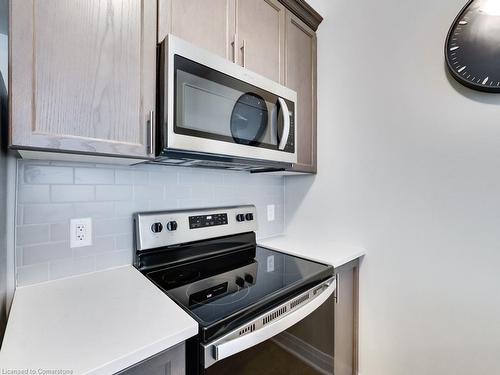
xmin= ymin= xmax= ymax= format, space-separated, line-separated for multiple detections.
xmin=286 ymin=0 xmax=500 ymax=375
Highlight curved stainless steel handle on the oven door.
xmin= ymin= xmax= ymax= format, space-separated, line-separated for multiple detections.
xmin=205 ymin=278 xmax=337 ymax=367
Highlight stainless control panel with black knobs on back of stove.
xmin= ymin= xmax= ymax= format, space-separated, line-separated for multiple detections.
xmin=134 ymin=205 xmax=257 ymax=251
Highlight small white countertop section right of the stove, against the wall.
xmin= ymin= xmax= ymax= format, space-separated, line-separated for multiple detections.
xmin=258 ymin=234 xmax=366 ymax=268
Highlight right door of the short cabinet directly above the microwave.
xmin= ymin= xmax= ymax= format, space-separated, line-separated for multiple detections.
xmin=236 ymin=0 xmax=285 ymax=83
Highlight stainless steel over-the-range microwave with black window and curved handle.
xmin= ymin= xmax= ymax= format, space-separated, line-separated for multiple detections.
xmin=155 ymin=35 xmax=297 ymax=171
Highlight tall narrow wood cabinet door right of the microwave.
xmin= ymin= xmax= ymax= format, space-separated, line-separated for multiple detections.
xmin=285 ymin=11 xmax=317 ymax=173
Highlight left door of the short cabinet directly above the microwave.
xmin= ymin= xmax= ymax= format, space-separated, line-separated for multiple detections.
xmin=158 ymin=0 xmax=238 ymax=60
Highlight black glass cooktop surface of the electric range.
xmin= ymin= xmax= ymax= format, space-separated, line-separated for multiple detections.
xmin=147 ymin=246 xmax=333 ymax=344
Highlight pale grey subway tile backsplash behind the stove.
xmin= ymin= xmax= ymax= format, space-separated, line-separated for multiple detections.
xmin=16 ymin=160 xmax=284 ymax=286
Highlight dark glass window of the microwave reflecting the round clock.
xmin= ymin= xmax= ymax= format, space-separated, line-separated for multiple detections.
xmin=174 ymin=55 xmax=292 ymax=149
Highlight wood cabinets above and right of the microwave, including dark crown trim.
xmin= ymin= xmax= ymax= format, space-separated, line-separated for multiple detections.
xmin=158 ymin=0 xmax=322 ymax=173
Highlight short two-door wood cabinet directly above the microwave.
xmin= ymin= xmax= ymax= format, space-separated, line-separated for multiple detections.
xmin=158 ymin=0 xmax=285 ymax=83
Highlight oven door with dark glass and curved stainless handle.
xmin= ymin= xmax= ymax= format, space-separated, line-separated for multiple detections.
xmin=202 ymin=278 xmax=336 ymax=374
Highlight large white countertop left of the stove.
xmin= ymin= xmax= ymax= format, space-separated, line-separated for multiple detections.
xmin=0 ymin=266 xmax=198 ymax=374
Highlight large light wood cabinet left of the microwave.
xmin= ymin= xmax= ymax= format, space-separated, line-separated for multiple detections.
xmin=9 ymin=0 xmax=157 ymax=159
